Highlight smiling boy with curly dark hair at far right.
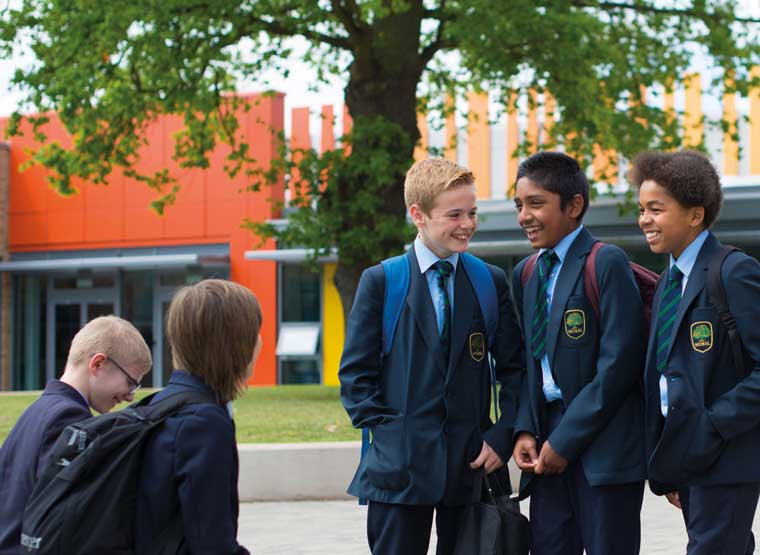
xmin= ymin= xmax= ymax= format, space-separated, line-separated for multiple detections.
xmin=631 ymin=151 xmax=760 ymax=555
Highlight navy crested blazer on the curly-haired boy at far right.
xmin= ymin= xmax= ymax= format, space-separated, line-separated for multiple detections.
xmin=645 ymin=233 xmax=760 ymax=493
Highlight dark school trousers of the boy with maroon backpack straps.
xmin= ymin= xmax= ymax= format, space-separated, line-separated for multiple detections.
xmin=530 ymin=401 xmax=644 ymax=555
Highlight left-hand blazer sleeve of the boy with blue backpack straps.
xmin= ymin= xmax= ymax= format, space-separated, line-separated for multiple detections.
xmin=338 ymin=266 xmax=393 ymax=428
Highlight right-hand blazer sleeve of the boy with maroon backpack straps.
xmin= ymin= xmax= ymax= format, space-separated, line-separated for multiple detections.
xmin=548 ymin=245 xmax=646 ymax=461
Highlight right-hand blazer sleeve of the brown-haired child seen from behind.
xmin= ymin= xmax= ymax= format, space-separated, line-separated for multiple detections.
xmin=174 ymin=404 xmax=248 ymax=555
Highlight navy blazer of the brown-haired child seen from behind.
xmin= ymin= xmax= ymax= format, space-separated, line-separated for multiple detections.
xmin=135 ymin=370 xmax=248 ymax=555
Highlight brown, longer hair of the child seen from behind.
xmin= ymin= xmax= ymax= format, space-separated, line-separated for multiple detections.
xmin=166 ymin=279 xmax=262 ymax=403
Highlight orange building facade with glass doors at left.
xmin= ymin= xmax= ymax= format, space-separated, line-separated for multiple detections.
xmin=0 ymin=94 xmax=284 ymax=389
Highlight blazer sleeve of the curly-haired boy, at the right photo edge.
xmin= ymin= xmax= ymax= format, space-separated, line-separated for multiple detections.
xmin=704 ymin=254 xmax=760 ymax=440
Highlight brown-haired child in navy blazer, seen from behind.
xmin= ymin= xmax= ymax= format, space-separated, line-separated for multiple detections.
xmin=135 ymin=279 xmax=262 ymax=555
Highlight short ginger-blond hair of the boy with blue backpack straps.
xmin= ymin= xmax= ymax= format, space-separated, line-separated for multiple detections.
xmin=404 ymin=158 xmax=475 ymax=214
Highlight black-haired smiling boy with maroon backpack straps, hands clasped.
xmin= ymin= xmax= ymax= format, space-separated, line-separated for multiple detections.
xmin=513 ymin=152 xmax=645 ymax=555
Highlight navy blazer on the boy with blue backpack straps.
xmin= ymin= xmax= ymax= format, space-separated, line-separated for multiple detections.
xmin=339 ymin=248 xmax=522 ymax=505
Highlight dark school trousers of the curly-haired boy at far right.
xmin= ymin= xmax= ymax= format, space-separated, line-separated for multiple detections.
xmin=678 ymin=483 xmax=760 ymax=555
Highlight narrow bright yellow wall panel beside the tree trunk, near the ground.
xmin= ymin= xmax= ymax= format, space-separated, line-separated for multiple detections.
xmin=322 ymin=263 xmax=345 ymax=385
